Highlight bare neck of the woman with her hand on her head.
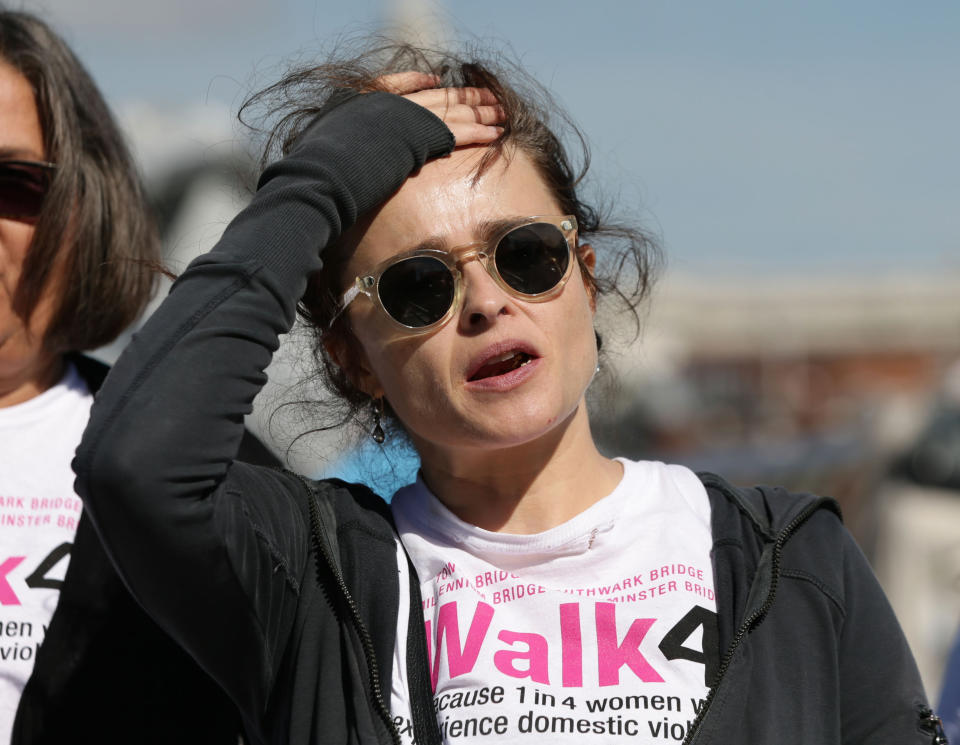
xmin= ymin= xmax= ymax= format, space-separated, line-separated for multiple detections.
xmin=417 ymin=402 xmax=623 ymax=534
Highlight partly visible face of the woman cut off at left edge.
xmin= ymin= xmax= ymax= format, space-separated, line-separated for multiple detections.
xmin=0 ymin=59 xmax=56 ymax=405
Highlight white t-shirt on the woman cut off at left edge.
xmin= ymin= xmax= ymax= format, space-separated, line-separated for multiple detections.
xmin=0 ymin=365 xmax=93 ymax=745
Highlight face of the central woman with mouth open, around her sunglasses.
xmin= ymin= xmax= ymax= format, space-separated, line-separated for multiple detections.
xmin=334 ymin=148 xmax=597 ymax=455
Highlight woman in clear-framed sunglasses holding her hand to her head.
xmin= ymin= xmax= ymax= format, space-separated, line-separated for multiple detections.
xmin=75 ymin=42 xmax=936 ymax=743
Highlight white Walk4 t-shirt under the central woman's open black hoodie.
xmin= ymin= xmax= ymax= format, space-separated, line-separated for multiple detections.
xmin=391 ymin=460 xmax=718 ymax=745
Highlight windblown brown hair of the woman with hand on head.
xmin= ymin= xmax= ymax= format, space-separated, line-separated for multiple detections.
xmin=240 ymin=38 xmax=659 ymax=438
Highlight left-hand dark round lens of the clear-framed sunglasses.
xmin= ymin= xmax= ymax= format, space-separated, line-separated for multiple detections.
xmin=377 ymin=256 xmax=454 ymax=328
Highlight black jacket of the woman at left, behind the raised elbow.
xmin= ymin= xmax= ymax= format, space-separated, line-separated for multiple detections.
xmin=11 ymin=355 xmax=278 ymax=745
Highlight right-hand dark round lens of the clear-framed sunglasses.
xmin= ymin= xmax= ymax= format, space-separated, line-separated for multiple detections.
xmin=495 ymin=222 xmax=570 ymax=295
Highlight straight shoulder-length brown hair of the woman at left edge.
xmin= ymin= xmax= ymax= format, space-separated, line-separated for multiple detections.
xmin=0 ymin=10 xmax=160 ymax=353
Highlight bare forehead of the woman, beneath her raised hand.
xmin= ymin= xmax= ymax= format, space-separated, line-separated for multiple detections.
xmin=349 ymin=148 xmax=560 ymax=271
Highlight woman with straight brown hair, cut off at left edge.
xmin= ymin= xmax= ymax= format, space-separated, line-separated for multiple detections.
xmin=0 ymin=10 xmax=266 ymax=744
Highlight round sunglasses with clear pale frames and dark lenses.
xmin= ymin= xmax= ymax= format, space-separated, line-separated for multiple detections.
xmin=330 ymin=215 xmax=577 ymax=334
